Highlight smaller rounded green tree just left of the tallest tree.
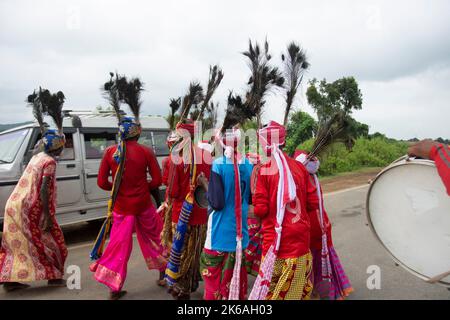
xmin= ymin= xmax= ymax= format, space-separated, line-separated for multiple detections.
xmin=285 ymin=111 xmax=317 ymax=154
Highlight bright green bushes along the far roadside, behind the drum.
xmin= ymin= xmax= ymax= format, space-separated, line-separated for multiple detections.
xmin=298 ymin=137 xmax=408 ymax=176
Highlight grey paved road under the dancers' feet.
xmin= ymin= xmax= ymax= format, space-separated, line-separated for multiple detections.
xmin=0 ymin=186 xmax=450 ymax=299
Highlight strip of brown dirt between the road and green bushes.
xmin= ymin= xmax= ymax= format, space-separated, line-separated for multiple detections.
xmin=320 ymin=168 xmax=382 ymax=193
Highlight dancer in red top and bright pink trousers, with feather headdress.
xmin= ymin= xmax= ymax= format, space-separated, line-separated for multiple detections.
xmin=90 ymin=74 xmax=166 ymax=300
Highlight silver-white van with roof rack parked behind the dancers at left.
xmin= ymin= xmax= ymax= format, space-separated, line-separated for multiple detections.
xmin=0 ymin=111 xmax=170 ymax=225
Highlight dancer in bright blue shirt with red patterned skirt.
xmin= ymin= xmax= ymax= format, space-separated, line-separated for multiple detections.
xmin=201 ymin=129 xmax=253 ymax=300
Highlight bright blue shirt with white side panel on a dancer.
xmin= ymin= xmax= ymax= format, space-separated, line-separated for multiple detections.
xmin=205 ymin=156 xmax=253 ymax=252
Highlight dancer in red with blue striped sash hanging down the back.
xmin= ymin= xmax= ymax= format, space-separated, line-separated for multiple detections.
xmin=166 ymin=120 xmax=212 ymax=300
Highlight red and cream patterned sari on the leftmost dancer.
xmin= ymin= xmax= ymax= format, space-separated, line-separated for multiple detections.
xmin=0 ymin=152 xmax=67 ymax=282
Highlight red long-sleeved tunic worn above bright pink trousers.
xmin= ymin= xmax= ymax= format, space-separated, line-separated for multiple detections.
xmin=97 ymin=141 xmax=161 ymax=215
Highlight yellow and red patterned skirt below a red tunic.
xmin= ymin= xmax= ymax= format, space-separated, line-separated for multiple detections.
xmin=266 ymin=253 xmax=313 ymax=300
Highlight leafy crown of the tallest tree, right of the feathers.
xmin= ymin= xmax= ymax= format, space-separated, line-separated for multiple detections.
xmin=306 ymin=77 xmax=362 ymax=123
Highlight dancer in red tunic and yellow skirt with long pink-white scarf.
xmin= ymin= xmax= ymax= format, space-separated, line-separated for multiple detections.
xmin=249 ymin=121 xmax=318 ymax=300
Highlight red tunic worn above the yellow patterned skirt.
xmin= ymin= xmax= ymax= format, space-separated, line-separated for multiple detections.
xmin=253 ymin=155 xmax=319 ymax=259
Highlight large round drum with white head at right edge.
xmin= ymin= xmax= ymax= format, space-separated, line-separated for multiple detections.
xmin=366 ymin=156 xmax=450 ymax=286
